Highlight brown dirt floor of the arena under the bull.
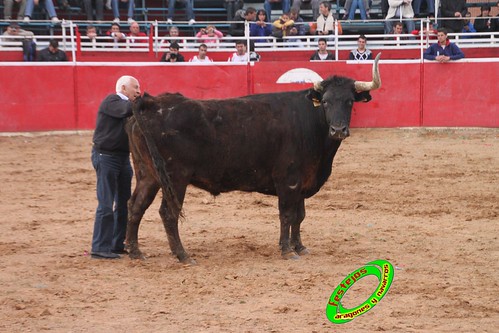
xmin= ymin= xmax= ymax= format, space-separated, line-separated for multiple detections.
xmin=0 ymin=129 xmax=499 ymax=333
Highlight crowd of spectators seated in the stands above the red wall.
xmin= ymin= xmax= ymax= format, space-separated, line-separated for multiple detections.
xmin=3 ymin=0 xmax=499 ymax=62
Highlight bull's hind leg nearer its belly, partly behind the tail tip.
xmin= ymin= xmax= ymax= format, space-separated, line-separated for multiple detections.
xmin=159 ymin=185 xmax=196 ymax=265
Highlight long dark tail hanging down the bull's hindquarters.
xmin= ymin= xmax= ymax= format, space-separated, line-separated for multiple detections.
xmin=132 ymin=93 xmax=183 ymax=217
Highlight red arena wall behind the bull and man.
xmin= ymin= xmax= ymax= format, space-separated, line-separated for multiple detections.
xmin=0 ymin=59 xmax=499 ymax=132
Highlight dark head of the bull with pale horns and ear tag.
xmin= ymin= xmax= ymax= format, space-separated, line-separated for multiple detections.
xmin=308 ymin=54 xmax=381 ymax=140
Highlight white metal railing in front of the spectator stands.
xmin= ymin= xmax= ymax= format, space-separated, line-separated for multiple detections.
xmin=0 ymin=19 xmax=499 ymax=61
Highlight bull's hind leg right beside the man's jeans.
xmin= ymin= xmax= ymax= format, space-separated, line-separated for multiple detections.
xmin=125 ymin=177 xmax=159 ymax=259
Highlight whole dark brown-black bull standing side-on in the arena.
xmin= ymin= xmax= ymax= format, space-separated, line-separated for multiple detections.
xmin=126 ymin=56 xmax=381 ymax=262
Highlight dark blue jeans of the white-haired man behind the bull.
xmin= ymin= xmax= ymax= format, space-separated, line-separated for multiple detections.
xmin=92 ymin=149 xmax=133 ymax=252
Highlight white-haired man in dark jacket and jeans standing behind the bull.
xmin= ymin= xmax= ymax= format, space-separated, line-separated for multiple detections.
xmin=91 ymin=76 xmax=140 ymax=259
